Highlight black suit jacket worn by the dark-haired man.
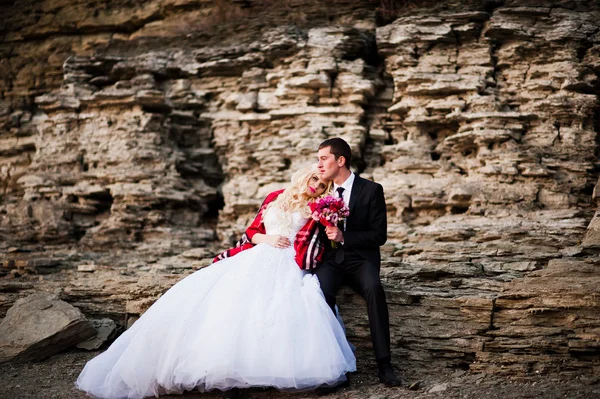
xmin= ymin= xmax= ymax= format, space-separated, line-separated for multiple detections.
xmin=326 ymin=176 xmax=387 ymax=268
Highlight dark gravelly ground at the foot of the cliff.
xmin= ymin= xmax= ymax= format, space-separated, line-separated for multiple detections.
xmin=0 ymin=350 xmax=600 ymax=399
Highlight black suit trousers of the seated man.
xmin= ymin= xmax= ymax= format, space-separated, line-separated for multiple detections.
xmin=315 ymin=249 xmax=391 ymax=364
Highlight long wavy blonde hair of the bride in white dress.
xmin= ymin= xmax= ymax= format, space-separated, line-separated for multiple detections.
xmin=267 ymin=168 xmax=333 ymax=218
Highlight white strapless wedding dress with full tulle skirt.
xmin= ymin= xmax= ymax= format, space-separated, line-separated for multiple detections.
xmin=76 ymin=208 xmax=356 ymax=398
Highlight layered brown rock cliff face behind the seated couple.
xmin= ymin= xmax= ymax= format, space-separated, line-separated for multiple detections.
xmin=0 ymin=0 xmax=600 ymax=374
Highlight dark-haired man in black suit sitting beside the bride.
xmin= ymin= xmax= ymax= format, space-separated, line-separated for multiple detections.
xmin=315 ymin=138 xmax=400 ymax=387
